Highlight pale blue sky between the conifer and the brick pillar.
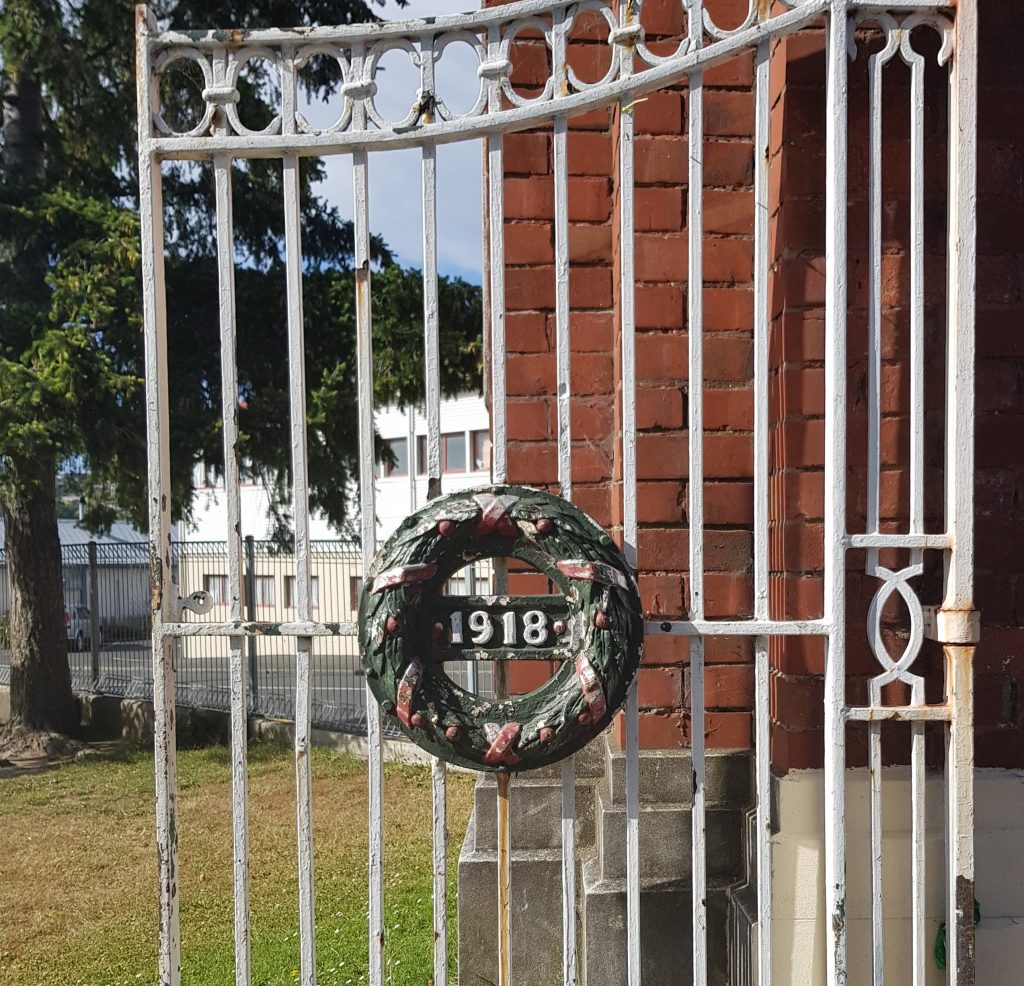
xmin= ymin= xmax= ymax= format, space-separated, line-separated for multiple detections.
xmin=305 ymin=0 xmax=481 ymax=284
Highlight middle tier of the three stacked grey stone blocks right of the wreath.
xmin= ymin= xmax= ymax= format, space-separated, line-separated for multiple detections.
xmin=595 ymin=785 xmax=743 ymax=887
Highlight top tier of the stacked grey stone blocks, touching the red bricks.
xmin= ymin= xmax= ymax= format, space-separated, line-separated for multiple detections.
xmin=605 ymin=748 xmax=754 ymax=807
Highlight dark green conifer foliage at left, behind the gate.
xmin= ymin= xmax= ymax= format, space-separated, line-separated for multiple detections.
xmin=0 ymin=0 xmax=481 ymax=527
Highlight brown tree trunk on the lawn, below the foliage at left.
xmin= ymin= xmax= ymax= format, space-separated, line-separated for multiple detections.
xmin=3 ymin=460 xmax=78 ymax=735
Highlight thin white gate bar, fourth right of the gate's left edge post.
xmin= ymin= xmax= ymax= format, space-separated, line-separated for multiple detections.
xmin=419 ymin=80 xmax=447 ymax=986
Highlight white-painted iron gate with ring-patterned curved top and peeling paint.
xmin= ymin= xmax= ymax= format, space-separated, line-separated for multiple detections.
xmin=137 ymin=0 xmax=978 ymax=986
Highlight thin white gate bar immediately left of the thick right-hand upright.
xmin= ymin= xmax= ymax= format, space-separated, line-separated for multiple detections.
xmin=744 ymin=30 xmax=772 ymax=986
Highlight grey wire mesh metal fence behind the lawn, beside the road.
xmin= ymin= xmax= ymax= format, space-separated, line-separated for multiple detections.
xmin=0 ymin=538 xmax=492 ymax=733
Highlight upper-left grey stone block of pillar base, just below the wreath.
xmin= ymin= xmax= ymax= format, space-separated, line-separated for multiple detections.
xmin=473 ymin=774 xmax=594 ymax=851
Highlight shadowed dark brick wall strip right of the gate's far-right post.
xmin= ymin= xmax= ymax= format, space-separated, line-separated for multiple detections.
xmin=975 ymin=0 xmax=1024 ymax=767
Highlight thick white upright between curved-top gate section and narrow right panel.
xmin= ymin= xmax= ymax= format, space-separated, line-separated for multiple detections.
xmin=824 ymin=0 xmax=849 ymax=986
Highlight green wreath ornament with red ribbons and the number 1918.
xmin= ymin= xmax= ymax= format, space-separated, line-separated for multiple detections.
xmin=359 ymin=486 xmax=643 ymax=771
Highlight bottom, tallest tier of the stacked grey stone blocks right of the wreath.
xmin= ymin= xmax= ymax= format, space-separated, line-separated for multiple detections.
xmin=581 ymin=858 xmax=728 ymax=986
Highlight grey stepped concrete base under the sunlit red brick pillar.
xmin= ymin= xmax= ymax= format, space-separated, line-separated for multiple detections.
xmin=459 ymin=740 xmax=751 ymax=986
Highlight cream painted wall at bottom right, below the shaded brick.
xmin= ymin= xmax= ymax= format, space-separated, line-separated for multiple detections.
xmin=754 ymin=768 xmax=1024 ymax=986
